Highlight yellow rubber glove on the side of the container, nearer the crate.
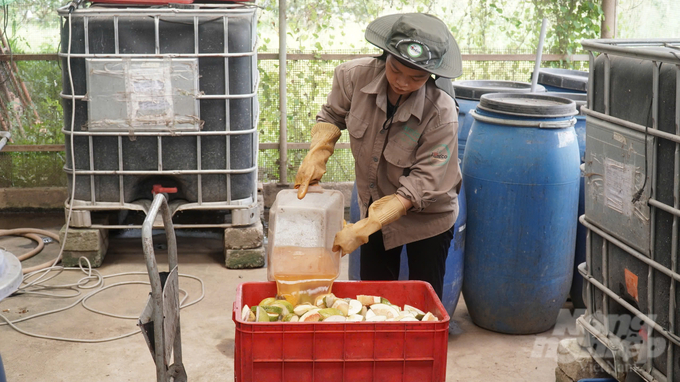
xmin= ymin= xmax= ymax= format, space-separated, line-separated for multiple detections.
xmin=333 ymin=194 xmax=406 ymax=256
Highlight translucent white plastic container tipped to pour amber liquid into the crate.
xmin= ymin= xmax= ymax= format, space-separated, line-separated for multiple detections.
xmin=267 ymin=188 xmax=345 ymax=302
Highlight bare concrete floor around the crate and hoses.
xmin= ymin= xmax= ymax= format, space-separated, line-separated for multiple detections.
xmin=0 ymin=213 xmax=575 ymax=382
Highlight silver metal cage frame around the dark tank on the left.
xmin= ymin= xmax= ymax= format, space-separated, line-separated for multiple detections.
xmin=58 ymin=4 xmax=259 ymax=229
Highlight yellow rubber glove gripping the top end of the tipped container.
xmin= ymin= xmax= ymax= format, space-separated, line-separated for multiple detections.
xmin=295 ymin=122 xmax=340 ymax=199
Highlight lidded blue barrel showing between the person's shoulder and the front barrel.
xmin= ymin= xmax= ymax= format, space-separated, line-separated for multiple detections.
xmin=453 ymin=80 xmax=545 ymax=160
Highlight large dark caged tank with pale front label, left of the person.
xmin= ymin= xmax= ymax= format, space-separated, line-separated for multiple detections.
xmin=60 ymin=4 xmax=257 ymax=212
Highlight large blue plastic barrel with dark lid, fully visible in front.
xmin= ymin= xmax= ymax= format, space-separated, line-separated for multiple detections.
xmin=463 ymin=94 xmax=580 ymax=334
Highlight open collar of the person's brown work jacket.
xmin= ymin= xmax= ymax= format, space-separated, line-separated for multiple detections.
xmin=361 ymin=62 xmax=430 ymax=122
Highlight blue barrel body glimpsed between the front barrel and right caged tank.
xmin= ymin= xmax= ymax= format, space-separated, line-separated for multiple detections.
xmin=546 ymin=92 xmax=588 ymax=309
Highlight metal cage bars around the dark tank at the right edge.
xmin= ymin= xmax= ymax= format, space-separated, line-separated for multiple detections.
xmin=578 ymin=39 xmax=680 ymax=382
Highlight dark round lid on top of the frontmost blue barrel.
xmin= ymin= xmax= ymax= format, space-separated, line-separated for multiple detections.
xmin=477 ymin=93 xmax=577 ymax=118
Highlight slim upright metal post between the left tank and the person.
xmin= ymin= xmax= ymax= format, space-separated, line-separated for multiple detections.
xmin=279 ymin=0 xmax=288 ymax=184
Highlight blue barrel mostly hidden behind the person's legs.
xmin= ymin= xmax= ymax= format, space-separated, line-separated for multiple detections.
xmin=349 ymin=179 xmax=467 ymax=317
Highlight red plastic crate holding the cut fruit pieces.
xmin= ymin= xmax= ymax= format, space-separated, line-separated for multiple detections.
xmin=232 ymin=281 xmax=449 ymax=382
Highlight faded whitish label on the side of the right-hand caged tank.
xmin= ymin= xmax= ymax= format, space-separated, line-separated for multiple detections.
xmin=604 ymin=158 xmax=635 ymax=216
